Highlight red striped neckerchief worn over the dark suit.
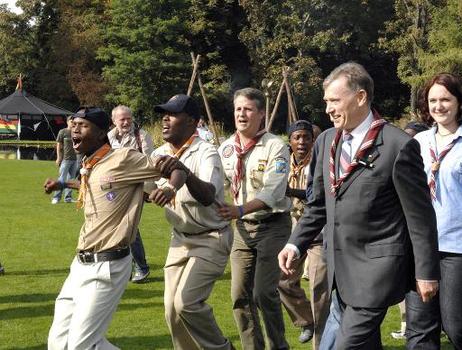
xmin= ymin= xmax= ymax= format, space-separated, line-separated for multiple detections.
xmin=329 ymin=111 xmax=387 ymax=197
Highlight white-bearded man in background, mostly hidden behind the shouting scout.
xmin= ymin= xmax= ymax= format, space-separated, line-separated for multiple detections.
xmin=107 ymin=105 xmax=154 ymax=283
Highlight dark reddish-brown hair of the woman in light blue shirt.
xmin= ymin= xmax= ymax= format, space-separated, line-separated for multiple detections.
xmin=419 ymin=73 xmax=462 ymax=126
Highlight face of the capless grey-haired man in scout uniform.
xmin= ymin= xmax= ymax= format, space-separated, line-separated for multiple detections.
xmin=234 ymin=95 xmax=265 ymax=139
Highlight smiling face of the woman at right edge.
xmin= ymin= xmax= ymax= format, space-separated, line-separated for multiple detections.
xmin=428 ymin=84 xmax=460 ymax=128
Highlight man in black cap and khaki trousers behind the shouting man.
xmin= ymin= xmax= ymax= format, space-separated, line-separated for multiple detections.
xmin=152 ymin=95 xmax=233 ymax=350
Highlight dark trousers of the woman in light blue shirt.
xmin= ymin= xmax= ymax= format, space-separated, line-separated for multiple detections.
xmin=406 ymin=253 xmax=462 ymax=350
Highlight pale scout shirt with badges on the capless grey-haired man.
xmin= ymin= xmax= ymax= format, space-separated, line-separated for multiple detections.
xmin=218 ymin=132 xmax=291 ymax=220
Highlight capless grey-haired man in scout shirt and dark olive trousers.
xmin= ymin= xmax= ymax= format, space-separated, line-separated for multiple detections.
xmin=218 ymin=88 xmax=291 ymax=350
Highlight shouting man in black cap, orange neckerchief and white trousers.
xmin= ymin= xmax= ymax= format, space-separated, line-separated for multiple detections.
xmin=44 ymin=107 xmax=186 ymax=350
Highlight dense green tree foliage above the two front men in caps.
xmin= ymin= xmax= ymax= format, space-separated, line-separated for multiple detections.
xmin=98 ymin=0 xmax=190 ymax=123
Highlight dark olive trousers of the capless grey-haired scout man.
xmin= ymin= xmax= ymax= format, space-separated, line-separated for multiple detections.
xmin=231 ymin=214 xmax=291 ymax=350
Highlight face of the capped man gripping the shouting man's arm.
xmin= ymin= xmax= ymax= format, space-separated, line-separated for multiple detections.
xmin=162 ymin=112 xmax=197 ymax=148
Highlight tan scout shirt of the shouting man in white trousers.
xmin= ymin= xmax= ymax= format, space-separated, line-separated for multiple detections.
xmin=77 ymin=148 xmax=160 ymax=252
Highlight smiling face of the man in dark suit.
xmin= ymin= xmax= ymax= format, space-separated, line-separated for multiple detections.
xmin=324 ymin=76 xmax=369 ymax=131
